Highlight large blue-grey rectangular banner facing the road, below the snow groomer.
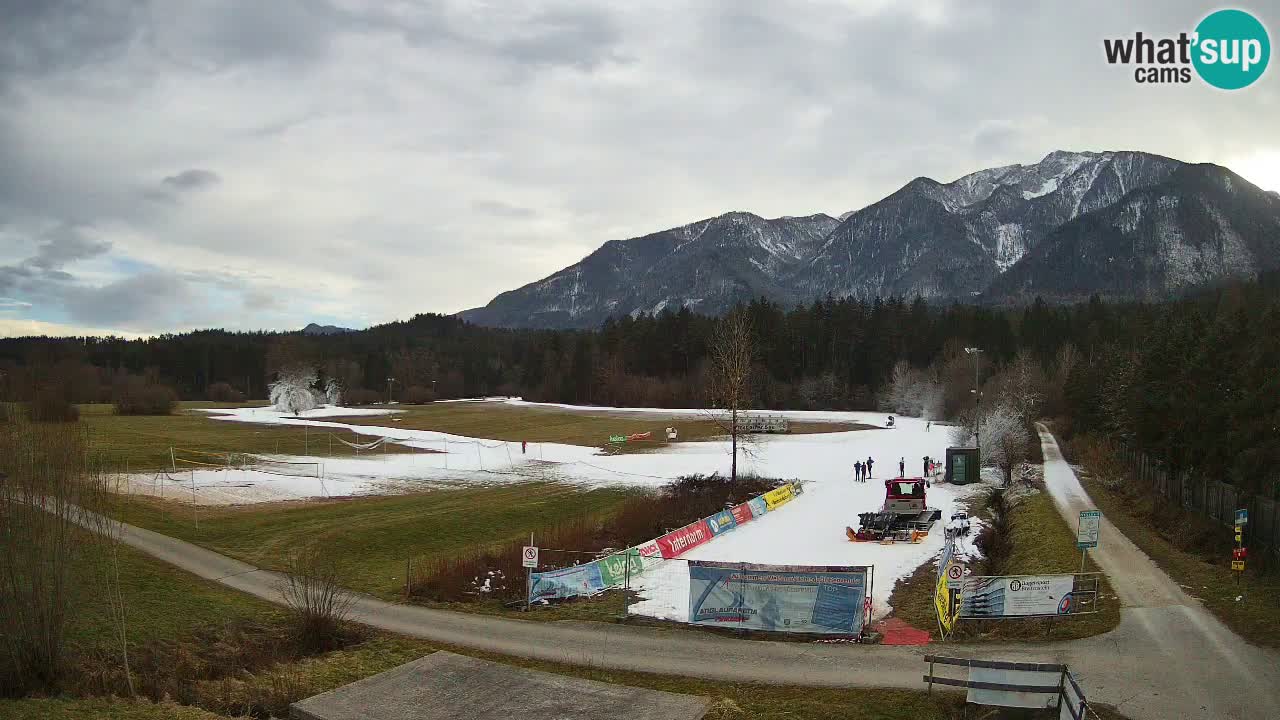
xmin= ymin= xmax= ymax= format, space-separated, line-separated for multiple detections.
xmin=689 ymin=560 xmax=869 ymax=635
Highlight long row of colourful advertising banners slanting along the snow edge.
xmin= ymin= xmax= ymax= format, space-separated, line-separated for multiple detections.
xmin=529 ymin=483 xmax=800 ymax=602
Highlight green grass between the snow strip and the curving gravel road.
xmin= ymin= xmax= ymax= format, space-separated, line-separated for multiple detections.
xmin=118 ymin=483 xmax=627 ymax=598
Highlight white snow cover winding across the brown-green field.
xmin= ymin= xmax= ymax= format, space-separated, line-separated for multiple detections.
xmin=131 ymin=400 xmax=977 ymax=620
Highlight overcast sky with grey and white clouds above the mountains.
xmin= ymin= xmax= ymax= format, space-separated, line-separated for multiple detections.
xmin=0 ymin=0 xmax=1280 ymax=336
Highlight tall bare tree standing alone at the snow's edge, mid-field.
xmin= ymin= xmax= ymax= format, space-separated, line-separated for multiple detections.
xmin=707 ymin=309 xmax=755 ymax=482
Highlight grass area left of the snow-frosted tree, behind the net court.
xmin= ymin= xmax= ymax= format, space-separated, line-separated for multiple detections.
xmin=79 ymin=402 xmax=411 ymax=473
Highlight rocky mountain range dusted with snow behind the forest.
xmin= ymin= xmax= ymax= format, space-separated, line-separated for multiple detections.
xmin=460 ymin=151 xmax=1280 ymax=328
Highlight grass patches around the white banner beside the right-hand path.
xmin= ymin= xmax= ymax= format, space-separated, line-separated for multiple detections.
xmin=890 ymin=481 xmax=1120 ymax=642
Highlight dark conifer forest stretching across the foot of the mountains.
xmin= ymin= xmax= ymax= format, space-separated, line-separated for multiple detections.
xmin=0 ymin=273 xmax=1280 ymax=496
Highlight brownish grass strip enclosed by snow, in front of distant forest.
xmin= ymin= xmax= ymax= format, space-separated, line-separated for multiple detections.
xmin=344 ymin=402 xmax=863 ymax=450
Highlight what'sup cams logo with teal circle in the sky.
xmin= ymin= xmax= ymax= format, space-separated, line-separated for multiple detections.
xmin=1102 ymin=10 xmax=1271 ymax=90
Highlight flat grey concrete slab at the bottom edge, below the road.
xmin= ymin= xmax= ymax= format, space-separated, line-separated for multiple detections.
xmin=289 ymin=652 xmax=710 ymax=720
